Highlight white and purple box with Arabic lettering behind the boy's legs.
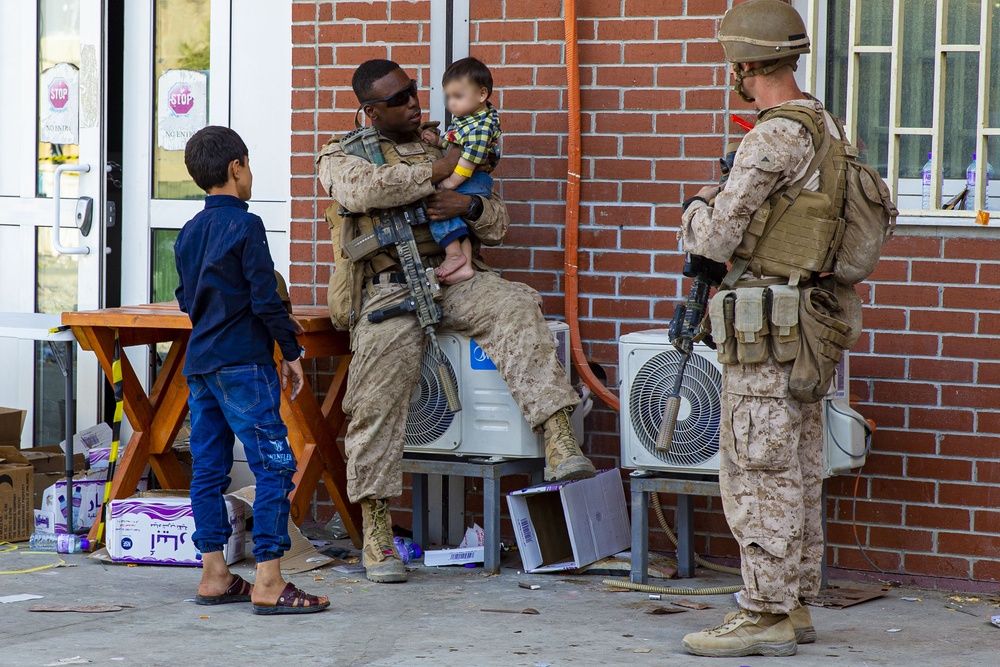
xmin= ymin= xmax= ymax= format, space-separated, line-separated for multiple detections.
xmin=106 ymin=491 xmax=246 ymax=566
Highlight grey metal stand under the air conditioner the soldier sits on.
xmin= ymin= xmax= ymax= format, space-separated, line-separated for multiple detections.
xmin=403 ymin=454 xmax=545 ymax=574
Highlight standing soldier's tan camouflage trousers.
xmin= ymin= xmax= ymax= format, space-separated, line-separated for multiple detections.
xmin=719 ymin=359 xmax=823 ymax=614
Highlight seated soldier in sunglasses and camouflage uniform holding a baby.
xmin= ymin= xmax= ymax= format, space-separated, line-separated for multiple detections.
xmin=317 ymin=61 xmax=594 ymax=582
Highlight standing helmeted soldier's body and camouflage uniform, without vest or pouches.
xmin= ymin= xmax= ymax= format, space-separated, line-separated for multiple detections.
xmin=679 ymin=0 xmax=836 ymax=656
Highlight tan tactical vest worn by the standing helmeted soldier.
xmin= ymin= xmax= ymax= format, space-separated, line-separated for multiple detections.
xmin=727 ymin=104 xmax=848 ymax=285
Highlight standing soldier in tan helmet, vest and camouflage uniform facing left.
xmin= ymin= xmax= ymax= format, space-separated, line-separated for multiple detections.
xmin=680 ymin=0 xmax=860 ymax=656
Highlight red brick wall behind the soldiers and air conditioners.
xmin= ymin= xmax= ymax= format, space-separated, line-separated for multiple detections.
xmin=291 ymin=0 xmax=1000 ymax=580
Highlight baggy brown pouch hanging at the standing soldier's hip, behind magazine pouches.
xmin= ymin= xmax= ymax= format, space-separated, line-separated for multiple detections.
xmin=788 ymin=287 xmax=853 ymax=403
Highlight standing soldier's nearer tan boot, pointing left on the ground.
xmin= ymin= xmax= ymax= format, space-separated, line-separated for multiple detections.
xmin=684 ymin=609 xmax=797 ymax=658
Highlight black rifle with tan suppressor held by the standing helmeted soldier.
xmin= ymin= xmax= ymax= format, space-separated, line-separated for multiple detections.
xmin=656 ymin=255 xmax=727 ymax=452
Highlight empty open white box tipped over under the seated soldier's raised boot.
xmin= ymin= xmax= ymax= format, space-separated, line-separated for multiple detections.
xmin=507 ymin=470 xmax=631 ymax=572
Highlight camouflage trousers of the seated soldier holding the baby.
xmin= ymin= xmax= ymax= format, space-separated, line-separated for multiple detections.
xmin=344 ymin=272 xmax=580 ymax=502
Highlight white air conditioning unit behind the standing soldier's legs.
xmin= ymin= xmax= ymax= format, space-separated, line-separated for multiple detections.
xmin=618 ymin=329 xmax=868 ymax=477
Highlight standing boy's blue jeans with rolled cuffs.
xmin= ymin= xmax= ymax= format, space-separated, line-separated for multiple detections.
xmin=187 ymin=364 xmax=295 ymax=563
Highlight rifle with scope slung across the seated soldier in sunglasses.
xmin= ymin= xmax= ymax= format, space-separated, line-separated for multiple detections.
xmin=368 ymin=201 xmax=462 ymax=412
